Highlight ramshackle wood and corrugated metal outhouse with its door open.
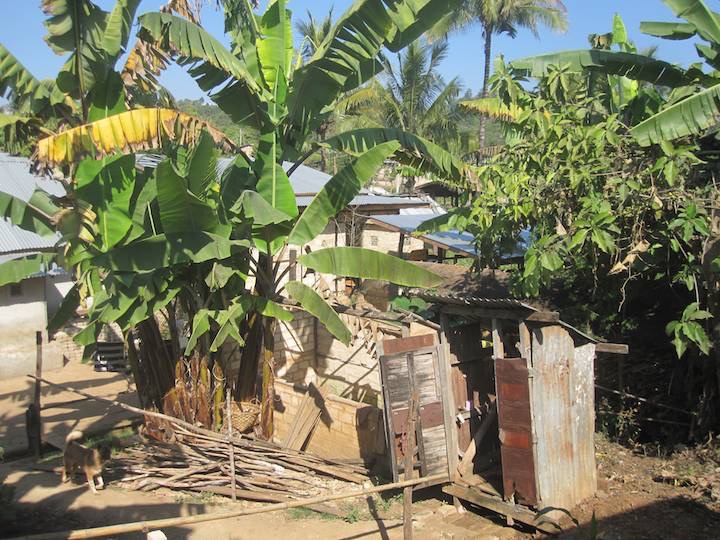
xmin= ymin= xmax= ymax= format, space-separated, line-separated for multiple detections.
xmin=379 ymin=268 xmax=627 ymax=528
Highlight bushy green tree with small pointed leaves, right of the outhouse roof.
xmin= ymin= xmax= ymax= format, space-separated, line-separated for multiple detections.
xmin=434 ymin=45 xmax=716 ymax=362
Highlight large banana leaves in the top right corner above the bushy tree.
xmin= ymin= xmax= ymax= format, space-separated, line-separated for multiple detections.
xmin=511 ymin=0 xmax=720 ymax=146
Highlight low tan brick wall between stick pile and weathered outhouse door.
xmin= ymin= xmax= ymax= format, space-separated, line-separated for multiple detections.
xmin=275 ymin=381 xmax=386 ymax=467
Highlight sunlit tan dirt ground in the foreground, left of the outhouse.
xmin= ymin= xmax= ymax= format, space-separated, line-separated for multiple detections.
xmin=0 ymin=452 xmax=517 ymax=540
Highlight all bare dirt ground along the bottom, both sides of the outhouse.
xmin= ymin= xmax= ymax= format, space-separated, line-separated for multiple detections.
xmin=0 ymin=438 xmax=720 ymax=540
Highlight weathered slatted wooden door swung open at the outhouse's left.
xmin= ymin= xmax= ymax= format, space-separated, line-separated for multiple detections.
xmin=380 ymin=334 xmax=448 ymax=481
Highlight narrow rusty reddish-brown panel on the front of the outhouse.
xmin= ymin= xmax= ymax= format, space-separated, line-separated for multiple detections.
xmin=495 ymin=358 xmax=537 ymax=505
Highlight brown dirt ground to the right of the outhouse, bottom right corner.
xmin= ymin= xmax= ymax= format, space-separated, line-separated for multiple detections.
xmin=560 ymin=438 xmax=720 ymax=540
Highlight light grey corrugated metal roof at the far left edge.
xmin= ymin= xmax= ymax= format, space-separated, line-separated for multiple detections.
xmin=0 ymin=152 xmax=65 ymax=255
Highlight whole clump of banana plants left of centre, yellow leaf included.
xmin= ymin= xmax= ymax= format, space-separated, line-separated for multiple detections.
xmin=8 ymin=0 xmax=462 ymax=436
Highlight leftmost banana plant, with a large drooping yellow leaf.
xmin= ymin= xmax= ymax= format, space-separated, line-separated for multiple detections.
xmin=0 ymin=0 xmax=225 ymax=292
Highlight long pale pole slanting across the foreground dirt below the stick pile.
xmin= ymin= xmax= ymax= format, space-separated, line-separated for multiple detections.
xmin=11 ymin=474 xmax=448 ymax=540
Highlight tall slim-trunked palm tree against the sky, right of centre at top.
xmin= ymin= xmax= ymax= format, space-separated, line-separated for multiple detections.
xmin=433 ymin=0 xmax=567 ymax=148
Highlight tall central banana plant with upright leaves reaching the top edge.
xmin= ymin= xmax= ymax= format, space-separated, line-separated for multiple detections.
xmin=38 ymin=0 xmax=472 ymax=437
